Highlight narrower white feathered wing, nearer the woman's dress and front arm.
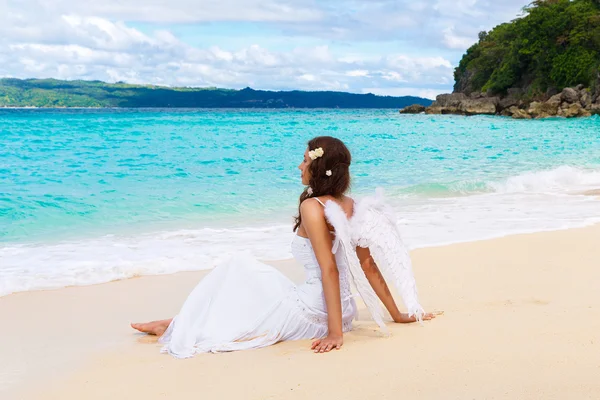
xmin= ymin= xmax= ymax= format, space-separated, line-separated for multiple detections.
xmin=325 ymin=201 xmax=388 ymax=333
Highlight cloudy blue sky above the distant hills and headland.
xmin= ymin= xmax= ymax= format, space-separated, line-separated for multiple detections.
xmin=0 ymin=0 xmax=530 ymax=98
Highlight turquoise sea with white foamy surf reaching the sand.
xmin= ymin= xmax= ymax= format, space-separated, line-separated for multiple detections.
xmin=0 ymin=109 xmax=600 ymax=295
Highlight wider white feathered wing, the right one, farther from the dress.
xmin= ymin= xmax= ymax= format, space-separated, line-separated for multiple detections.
xmin=350 ymin=189 xmax=424 ymax=321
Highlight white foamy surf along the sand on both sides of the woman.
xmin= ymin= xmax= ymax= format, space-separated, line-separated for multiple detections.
xmin=0 ymin=184 xmax=600 ymax=296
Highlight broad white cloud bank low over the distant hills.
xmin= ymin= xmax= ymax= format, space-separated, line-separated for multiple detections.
xmin=0 ymin=16 xmax=452 ymax=92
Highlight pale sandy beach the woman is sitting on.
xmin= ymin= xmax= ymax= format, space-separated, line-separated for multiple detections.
xmin=0 ymin=225 xmax=600 ymax=400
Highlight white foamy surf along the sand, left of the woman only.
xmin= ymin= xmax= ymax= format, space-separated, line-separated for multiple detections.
xmin=0 ymin=225 xmax=292 ymax=296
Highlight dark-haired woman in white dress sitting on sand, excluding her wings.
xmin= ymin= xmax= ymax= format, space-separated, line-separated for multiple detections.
xmin=132 ymin=136 xmax=433 ymax=358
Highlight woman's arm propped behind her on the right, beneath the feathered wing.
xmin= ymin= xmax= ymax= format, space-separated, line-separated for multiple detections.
xmin=356 ymin=247 xmax=433 ymax=323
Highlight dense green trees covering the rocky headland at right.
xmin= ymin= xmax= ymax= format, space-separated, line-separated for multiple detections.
xmin=454 ymin=0 xmax=600 ymax=98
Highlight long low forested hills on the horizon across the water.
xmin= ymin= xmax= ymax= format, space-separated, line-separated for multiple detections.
xmin=0 ymin=78 xmax=431 ymax=108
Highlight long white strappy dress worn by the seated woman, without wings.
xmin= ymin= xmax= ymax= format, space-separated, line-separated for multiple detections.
xmin=160 ymin=236 xmax=357 ymax=358
